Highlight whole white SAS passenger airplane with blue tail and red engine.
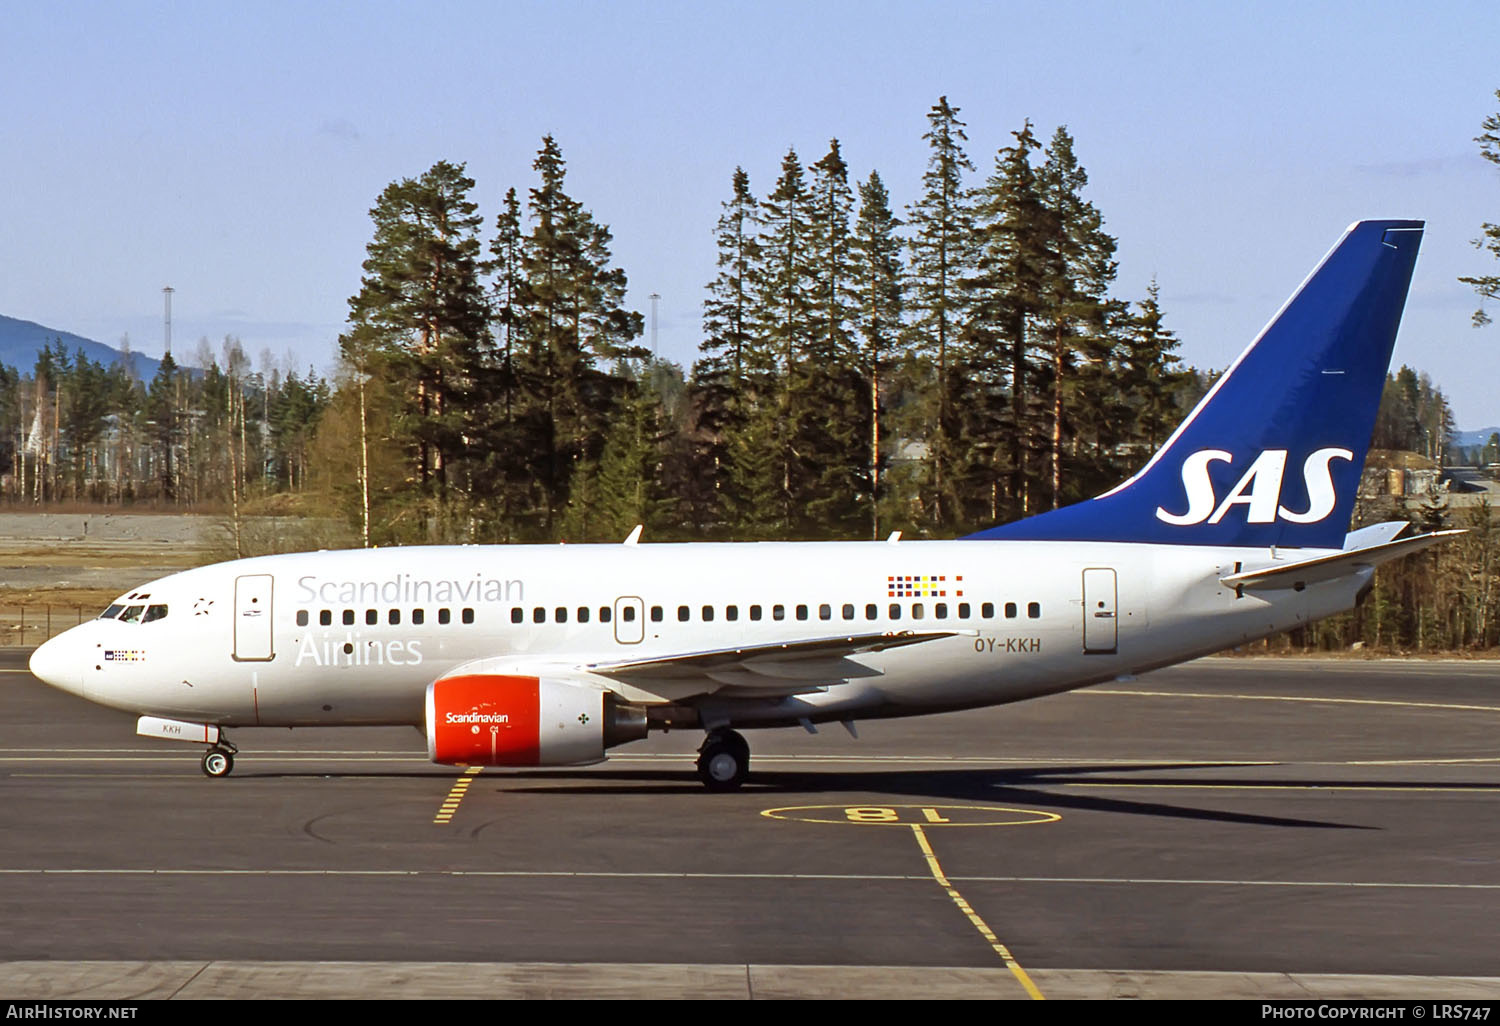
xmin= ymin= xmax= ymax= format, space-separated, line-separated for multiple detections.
xmin=30 ymin=221 xmax=1458 ymax=791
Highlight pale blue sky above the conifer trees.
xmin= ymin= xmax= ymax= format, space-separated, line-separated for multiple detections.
xmin=0 ymin=0 xmax=1500 ymax=431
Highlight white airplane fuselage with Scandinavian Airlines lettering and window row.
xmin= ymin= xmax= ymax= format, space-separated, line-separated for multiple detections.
xmin=33 ymin=542 xmax=1370 ymax=726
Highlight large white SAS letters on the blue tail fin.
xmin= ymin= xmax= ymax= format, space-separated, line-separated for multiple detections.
xmin=1157 ymin=449 xmax=1355 ymax=527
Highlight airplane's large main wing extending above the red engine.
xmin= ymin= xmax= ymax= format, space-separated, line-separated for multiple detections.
xmin=584 ymin=630 xmax=972 ymax=698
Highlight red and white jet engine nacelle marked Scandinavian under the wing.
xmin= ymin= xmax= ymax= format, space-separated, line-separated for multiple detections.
xmin=428 ymin=674 xmax=647 ymax=767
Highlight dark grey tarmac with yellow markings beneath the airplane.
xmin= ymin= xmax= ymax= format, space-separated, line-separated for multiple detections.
xmin=0 ymin=650 xmax=1500 ymax=1001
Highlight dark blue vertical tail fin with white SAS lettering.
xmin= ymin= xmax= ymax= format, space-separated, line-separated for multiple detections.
xmin=969 ymin=221 xmax=1424 ymax=549
